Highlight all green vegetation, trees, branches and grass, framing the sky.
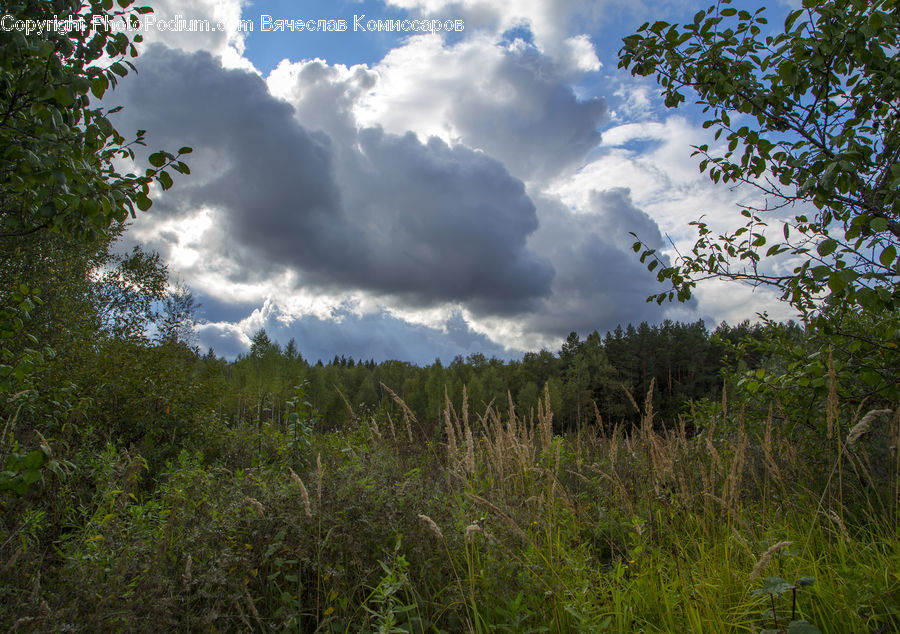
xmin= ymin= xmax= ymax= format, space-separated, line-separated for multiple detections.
xmin=0 ymin=0 xmax=900 ymax=634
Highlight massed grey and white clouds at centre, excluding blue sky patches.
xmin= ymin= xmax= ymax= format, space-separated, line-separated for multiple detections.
xmin=110 ymin=0 xmax=716 ymax=363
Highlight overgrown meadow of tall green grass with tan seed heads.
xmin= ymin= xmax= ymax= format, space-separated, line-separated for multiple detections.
xmin=0 ymin=385 xmax=900 ymax=633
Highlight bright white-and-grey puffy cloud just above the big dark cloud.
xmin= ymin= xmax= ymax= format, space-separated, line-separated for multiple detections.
xmin=357 ymin=36 xmax=607 ymax=180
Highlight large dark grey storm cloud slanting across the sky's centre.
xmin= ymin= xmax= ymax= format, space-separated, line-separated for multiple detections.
xmin=115 ymin=46 xmax=553 ymax=312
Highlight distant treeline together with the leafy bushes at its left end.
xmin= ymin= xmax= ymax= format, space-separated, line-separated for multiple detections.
xmin=0 ymin=220 xmax=802 ymax=477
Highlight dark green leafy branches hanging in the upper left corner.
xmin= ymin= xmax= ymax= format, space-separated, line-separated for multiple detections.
xmin=0 ymin=0 xmax=191 ymax=239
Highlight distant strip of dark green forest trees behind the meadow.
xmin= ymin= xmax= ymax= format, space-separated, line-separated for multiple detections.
xmin=214 ymin=321 xmax=784 ymax=431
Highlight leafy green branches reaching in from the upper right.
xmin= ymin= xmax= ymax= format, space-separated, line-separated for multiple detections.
xmin=619 ymin=0 xmax=900 ymax=318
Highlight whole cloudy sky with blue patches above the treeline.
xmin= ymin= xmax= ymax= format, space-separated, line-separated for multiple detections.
xmin=104 ymin=0 xmax=793 ymax=365
